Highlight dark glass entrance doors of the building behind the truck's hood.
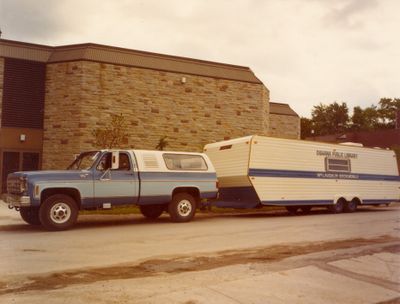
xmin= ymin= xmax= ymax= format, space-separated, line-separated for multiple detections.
xmin=1 ymin=152 xmax=40 ymax=193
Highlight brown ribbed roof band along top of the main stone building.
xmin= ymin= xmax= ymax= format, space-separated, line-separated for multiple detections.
xmin=0 ymin=39 xmax=262 ymax=84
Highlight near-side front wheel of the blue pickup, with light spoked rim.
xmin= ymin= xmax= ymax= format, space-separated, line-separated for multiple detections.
xmin=39 ymin=194 xmax=78 ymax=231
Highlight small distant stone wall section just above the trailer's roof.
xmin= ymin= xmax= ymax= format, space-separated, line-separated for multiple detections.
xmin=268 ymin=114 xmax=300 ymax=139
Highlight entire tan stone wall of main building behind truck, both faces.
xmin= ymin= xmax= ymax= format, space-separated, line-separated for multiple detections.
xmin=43 ymin=61 xmax=270 ymax=169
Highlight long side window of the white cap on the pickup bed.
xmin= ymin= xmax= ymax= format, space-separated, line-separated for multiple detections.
xmin=163 ymin=154 xmax=207 ymax=171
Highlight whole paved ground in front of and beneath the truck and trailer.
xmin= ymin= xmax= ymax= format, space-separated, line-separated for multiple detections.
xmin=0 ymin=204 xmax=400 ymax=303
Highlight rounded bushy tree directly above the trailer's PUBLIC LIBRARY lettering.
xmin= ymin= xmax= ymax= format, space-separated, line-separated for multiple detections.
xmin=311 ymin=102 xmax=349 ymax=135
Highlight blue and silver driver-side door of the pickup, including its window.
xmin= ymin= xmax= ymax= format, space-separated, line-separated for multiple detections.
xmin=94 ymin=152 xmax=139 ymax=206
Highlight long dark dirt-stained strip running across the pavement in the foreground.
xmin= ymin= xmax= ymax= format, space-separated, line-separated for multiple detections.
xmin=0 ymin=235 xmax=400 ymax=295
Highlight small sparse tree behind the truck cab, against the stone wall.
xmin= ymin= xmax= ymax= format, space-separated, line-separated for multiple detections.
xmin=92 ymin=114 xmax=128 ymax=149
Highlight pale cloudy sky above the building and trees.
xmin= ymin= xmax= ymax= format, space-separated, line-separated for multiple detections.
xmin=0 ymin=0 xmax=400 ymax=117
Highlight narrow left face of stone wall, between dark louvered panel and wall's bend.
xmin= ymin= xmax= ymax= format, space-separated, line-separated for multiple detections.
xmin=42 ymin=62 xmax=85 ymax=169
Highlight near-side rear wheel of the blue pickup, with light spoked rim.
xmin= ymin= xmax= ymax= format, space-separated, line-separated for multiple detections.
xmin=168 ymin=193 xmax=196 ymax=223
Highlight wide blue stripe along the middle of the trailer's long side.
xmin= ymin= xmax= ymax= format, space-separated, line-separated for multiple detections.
xmin=249 ymin=168 xmax=400 ymax=181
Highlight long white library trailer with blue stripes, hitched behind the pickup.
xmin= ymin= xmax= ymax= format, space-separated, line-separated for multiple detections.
xmin=204 ymin=135 xmax=400 ymax=213
